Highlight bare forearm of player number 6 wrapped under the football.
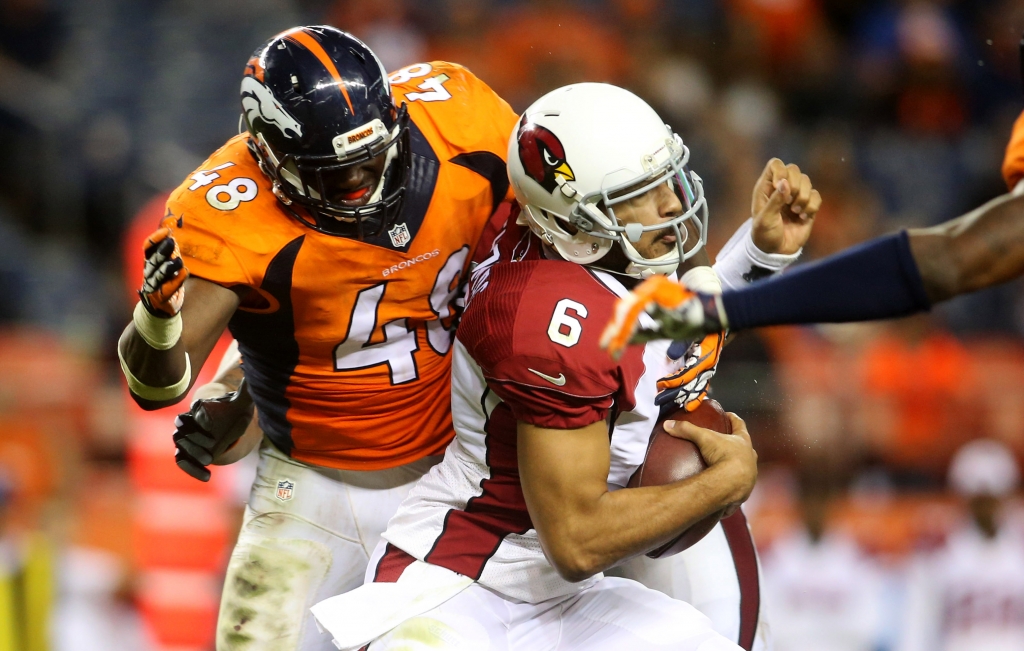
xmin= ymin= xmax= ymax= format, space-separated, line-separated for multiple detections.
xmin=535 ymin=464 xmax=743 ymax=581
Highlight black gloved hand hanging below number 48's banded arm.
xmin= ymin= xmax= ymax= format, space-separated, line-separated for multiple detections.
xmin=173 ymin=379 xmax=253 ymax=481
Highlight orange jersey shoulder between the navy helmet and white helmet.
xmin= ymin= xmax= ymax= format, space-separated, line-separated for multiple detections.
xmin=390 ymin=61 xmax=519 ymax=201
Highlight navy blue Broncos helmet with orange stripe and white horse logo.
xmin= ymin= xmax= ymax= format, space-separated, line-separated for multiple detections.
xmin=242 ymin=26 xmax=411 ymax=240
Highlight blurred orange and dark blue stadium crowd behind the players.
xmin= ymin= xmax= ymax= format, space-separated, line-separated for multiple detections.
xmin=0 ymin=0 xmax=1024 ymax=651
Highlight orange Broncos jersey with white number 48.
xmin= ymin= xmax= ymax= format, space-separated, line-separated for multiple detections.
xmin=167 ymin=61 xmax=518 ymax=470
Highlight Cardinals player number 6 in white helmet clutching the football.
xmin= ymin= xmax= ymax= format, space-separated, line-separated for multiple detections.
xmin=313 ymin=84 xmax=820 ymax=651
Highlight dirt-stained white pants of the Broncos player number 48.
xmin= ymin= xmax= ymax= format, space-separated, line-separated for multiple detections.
xmin=217 ymin=440 xmax=441 ymax=651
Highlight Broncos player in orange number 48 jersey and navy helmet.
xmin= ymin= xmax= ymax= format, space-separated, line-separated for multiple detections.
xmin=118 ymin=27 xmax=517 ymax=651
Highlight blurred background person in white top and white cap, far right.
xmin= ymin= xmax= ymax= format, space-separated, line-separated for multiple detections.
xmin=899 ymin=439 xmax=1024 ymax=651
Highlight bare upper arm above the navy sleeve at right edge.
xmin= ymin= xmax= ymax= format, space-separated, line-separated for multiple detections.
xmin=909 ymin=190 xmax=1024 ymax=303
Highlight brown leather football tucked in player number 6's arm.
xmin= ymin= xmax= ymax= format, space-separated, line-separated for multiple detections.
xmin=628 ymin=399 xmax=732 ymax=558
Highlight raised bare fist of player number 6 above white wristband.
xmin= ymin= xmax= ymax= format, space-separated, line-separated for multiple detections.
xmin=751 ymin=159 xmax=821 ymax=255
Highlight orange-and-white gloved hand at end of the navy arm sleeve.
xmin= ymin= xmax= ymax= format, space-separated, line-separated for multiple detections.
xmin=601 ymin=275 xmax=729 ymax=363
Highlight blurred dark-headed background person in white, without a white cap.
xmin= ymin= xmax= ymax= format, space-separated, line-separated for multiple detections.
xmin=764 ymin=482 xmax=883 ymax=651
